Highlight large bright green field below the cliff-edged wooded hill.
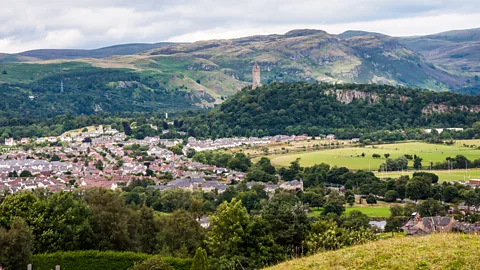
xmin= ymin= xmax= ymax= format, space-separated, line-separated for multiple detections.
xmin=270 ymin=140 xmax=480 ymax=171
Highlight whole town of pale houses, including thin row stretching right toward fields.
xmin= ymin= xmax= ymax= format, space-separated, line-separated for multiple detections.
xmin=0 ymin=125 xmax=308 ymax=194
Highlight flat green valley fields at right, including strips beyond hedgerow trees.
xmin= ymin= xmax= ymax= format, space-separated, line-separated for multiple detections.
xmin=269 ymin=140 xmax=480 ymax=181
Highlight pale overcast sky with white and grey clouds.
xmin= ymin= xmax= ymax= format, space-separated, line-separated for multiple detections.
xmin=0 ymin=0 xmax=480 ymax=53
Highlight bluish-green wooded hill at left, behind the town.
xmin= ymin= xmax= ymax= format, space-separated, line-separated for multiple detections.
xmin=0 ymin=67 xmax=198 ymax=119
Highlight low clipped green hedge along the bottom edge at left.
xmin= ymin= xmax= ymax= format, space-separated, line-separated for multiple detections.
xmin=33 ymin=250 xmax=192 ymax=270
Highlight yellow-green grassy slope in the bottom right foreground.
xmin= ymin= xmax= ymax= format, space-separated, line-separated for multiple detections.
xmin=268 ymin=234 xmax=480 ymax=270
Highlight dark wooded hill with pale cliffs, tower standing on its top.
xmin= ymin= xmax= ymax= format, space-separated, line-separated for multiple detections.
xmin=181 ymin=82 xmax=480 ymax=138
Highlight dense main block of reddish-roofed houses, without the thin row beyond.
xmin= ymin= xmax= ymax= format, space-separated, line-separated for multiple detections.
xmin=0 ymin=134 xmax=270 ymax=193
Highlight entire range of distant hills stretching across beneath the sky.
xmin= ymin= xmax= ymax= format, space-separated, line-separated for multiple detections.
xmin=0 ymin=29 xmax=480 ymax=117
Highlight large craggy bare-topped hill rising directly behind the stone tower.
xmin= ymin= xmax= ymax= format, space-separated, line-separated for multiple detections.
xmin=152 ymin=30 xmax=467 ymax=90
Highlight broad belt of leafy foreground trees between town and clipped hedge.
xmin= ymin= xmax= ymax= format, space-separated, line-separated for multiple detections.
xmin=0 ymin=182 xmax=376 ymax=269
